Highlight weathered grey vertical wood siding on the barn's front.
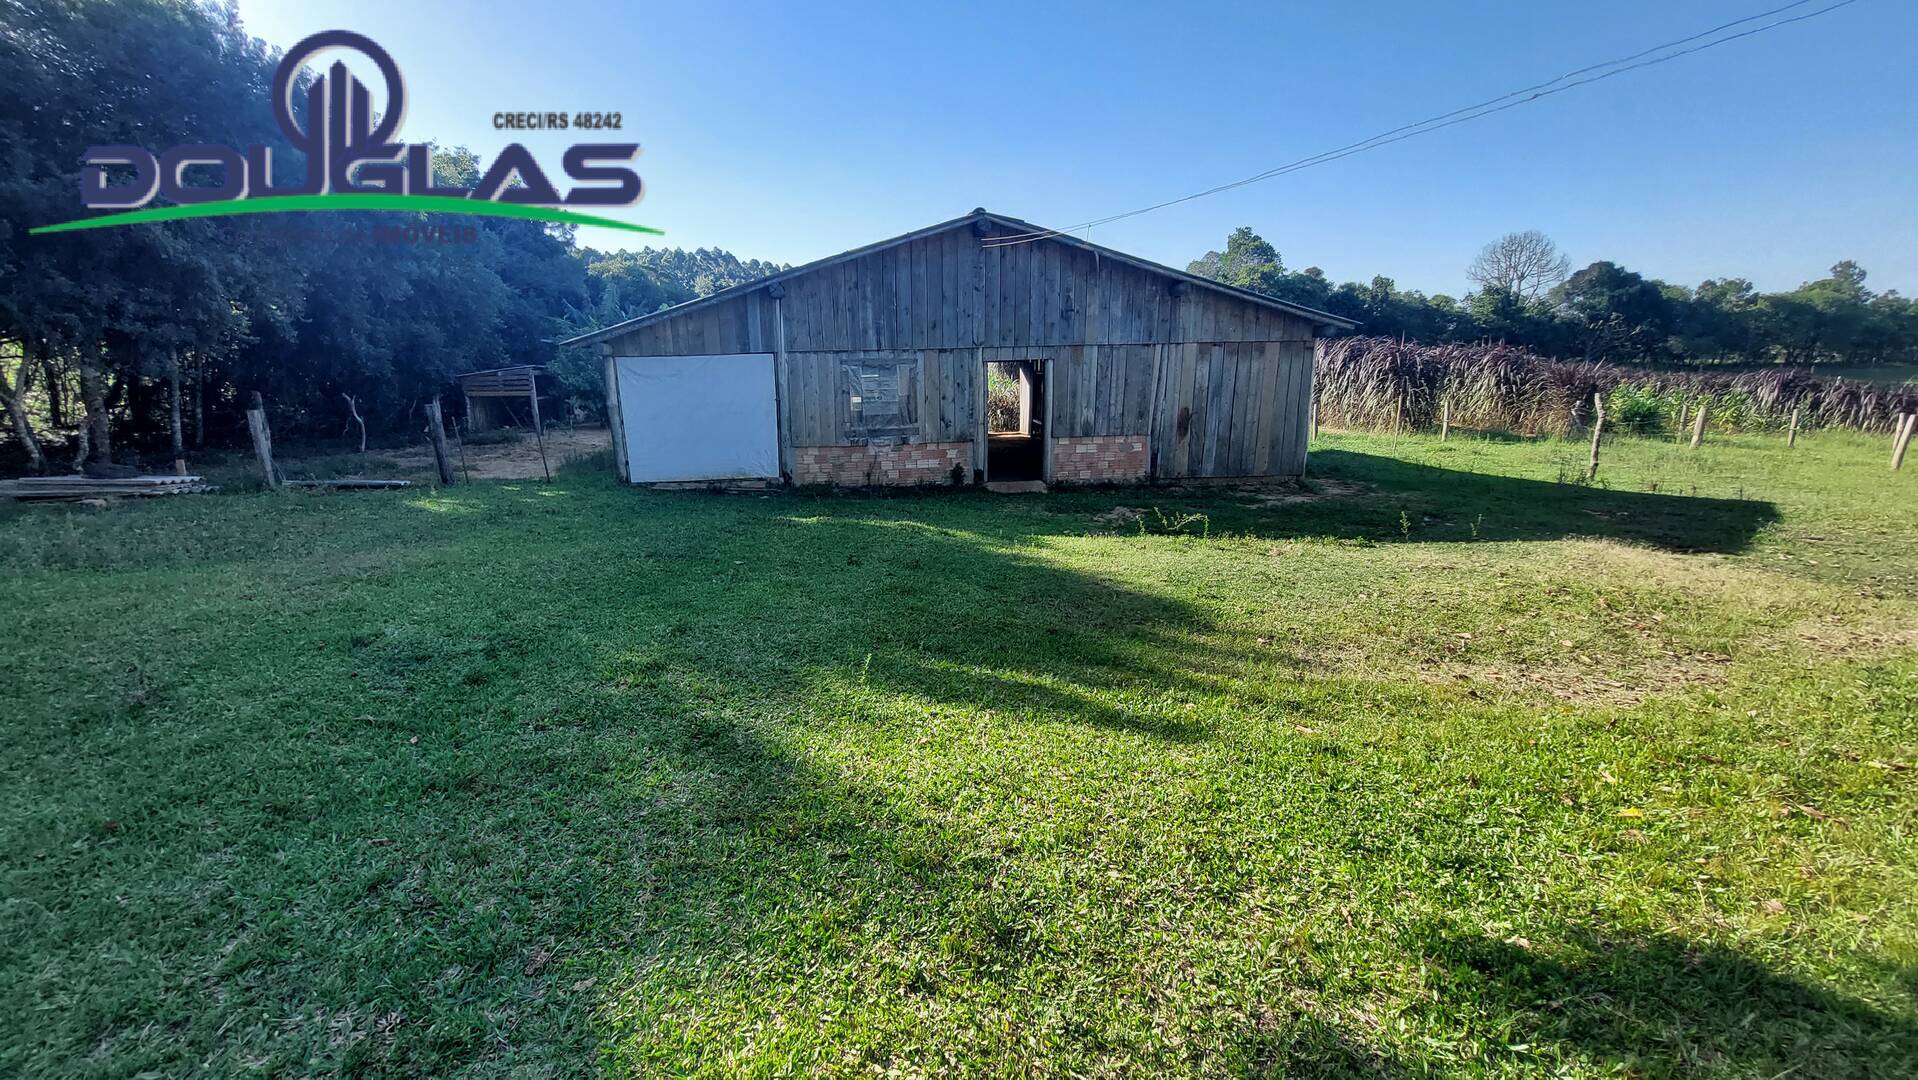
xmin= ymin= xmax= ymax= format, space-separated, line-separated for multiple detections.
xmin=604 ymin=226 xmax=1314 ymax=478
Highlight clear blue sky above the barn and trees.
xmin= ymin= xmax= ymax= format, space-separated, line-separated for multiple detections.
xmin=240 ymin=0 xmax=1918 ymax=293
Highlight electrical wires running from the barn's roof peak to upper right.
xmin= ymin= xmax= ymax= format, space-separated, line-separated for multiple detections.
xmin=984 ymin=0 xmax=1859 ymax=247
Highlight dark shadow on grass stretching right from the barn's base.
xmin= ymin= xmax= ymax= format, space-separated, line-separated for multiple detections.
xmin=1072 ymin=451 xmax=1778 ymax=554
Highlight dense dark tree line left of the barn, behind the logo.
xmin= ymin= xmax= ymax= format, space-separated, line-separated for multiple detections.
xmin=0 ymin=0 xmax=775 ymax=468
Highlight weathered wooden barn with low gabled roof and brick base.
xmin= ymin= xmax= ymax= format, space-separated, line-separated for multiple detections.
xmin=566 ymin=209 xmax=1352 ymax=485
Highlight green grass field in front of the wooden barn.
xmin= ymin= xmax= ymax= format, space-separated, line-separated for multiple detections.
xmin=0 ymin=434 xmax=1918 ymax=1078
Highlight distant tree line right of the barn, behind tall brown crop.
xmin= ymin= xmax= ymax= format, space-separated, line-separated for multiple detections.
xmin=1187 ymin=228 xmax=1918 ymax=364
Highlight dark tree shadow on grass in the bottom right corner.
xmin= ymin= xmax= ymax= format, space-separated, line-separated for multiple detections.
xmin=1241 ymin=927 xmax=1918 ymax=1080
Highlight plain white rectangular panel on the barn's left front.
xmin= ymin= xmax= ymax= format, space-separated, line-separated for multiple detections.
xmin=614 ymin=353 xmax=779 ymax=483
